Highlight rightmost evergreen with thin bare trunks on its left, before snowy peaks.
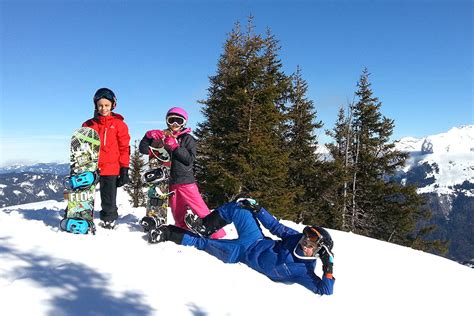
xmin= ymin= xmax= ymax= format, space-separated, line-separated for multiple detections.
xmin=328 ymin=69 xmax=440 ymax=247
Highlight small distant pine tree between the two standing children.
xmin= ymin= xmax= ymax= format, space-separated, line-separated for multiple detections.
xmin=124 ymin=141 xmax=146 ymax=207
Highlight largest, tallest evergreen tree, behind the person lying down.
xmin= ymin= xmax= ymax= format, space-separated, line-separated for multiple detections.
xmin=196 ymin=17 xmax=292 ymax=216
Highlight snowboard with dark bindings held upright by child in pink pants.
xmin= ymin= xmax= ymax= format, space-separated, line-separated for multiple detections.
xmin=140 ymin=140 xmax=174 ymax=233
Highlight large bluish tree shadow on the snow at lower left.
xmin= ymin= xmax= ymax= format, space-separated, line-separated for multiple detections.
xmin=0 ymin=240 xmax=154 ymax=315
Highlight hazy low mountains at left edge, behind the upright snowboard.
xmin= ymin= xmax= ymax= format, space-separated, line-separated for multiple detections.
xmin=0 ymin=163 xmax=69 ymax=207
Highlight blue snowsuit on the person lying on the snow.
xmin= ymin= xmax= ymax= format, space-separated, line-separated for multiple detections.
xmin=181 ymin=202 xmax=335 ymax=295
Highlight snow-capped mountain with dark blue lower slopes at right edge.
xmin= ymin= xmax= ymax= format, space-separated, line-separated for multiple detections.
xmin=396 ymin=125 xmax=474 ymax=263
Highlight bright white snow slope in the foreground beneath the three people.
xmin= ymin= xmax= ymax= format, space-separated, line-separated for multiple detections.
xmin=0 ymin=190 xmax=474 ymax=316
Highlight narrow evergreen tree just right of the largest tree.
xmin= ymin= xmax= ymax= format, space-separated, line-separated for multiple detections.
xmin=285 ymin=67 xmax=323 ymax=222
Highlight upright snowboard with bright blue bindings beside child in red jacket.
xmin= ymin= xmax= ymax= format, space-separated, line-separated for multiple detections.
xmin=60 ymin=127 xmax=100 ymax=234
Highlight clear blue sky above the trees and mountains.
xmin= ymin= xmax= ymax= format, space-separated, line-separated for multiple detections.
xmin=0 ymin=0 xmax=474 ymax=165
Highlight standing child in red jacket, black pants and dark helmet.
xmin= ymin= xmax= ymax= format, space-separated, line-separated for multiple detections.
xmin=82 ymin=88 xmax=130 ymax=229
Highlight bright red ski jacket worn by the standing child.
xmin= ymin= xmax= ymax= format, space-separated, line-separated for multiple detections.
xmin=82 ymin=113 xmax=130 ymax=176
